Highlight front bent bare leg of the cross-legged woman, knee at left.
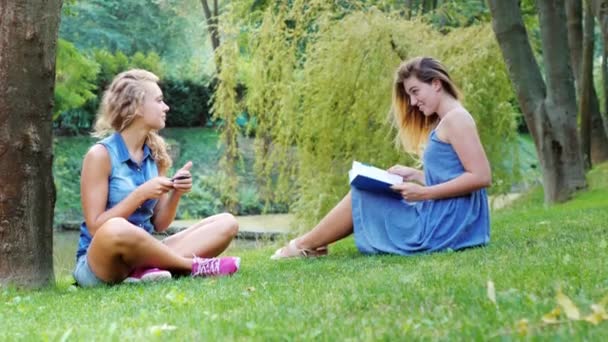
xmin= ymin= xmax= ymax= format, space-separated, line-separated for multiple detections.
xmin=87 ymin=218 xmax=192 ymax=283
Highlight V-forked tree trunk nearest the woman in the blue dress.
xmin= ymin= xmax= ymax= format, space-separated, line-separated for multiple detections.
xmin=488 ymin=0 xmax=586 ymax=203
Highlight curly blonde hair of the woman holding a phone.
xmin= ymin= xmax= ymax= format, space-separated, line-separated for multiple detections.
xmin=92 ymin=69 xmax=172 ymax=174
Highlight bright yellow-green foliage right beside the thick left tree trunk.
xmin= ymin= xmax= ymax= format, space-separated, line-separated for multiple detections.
xmin=53 ymin=39 xmax=99 ymax=120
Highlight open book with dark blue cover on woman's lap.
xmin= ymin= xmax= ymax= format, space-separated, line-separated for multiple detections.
xmin=348 ymin=161 xmax=403 ymax=198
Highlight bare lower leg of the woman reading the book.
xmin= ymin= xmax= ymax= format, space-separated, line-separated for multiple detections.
xmin=296 ymin=191 xmax=353 ymax=249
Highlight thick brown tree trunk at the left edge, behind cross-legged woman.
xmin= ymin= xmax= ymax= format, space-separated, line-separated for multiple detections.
xmin=0 ymin=0 xmax=62 ymax=287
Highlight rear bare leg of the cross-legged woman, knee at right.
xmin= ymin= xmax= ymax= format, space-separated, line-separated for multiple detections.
xmin=163 ymin=213 xmax=239 ymax=258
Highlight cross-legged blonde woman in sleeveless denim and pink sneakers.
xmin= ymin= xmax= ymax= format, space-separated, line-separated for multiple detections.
xmin=74 ymin=70 xmax=240 ymax=286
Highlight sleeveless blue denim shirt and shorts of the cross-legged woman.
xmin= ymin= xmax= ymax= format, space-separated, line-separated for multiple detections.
xmin=76 ymin=132 xmax=158 ymax=259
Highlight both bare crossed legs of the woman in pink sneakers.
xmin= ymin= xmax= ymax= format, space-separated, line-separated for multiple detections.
xmin=87 ymin=214 xmax=238 ymax=283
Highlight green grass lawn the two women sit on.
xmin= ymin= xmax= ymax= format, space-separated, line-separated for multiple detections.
xmin=5 ymin=165 xmax=608 ymax=341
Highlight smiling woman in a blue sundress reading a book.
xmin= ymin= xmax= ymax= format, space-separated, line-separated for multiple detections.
xmin=272 ymin=57 xmax=491 ymax=259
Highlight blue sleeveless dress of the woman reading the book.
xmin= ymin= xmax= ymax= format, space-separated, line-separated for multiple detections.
xmin=351 ymin=131 xmax=490 ymax=255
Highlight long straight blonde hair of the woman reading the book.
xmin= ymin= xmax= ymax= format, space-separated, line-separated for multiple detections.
xmin=392 ymin=57 xmax=460 ymax=154
